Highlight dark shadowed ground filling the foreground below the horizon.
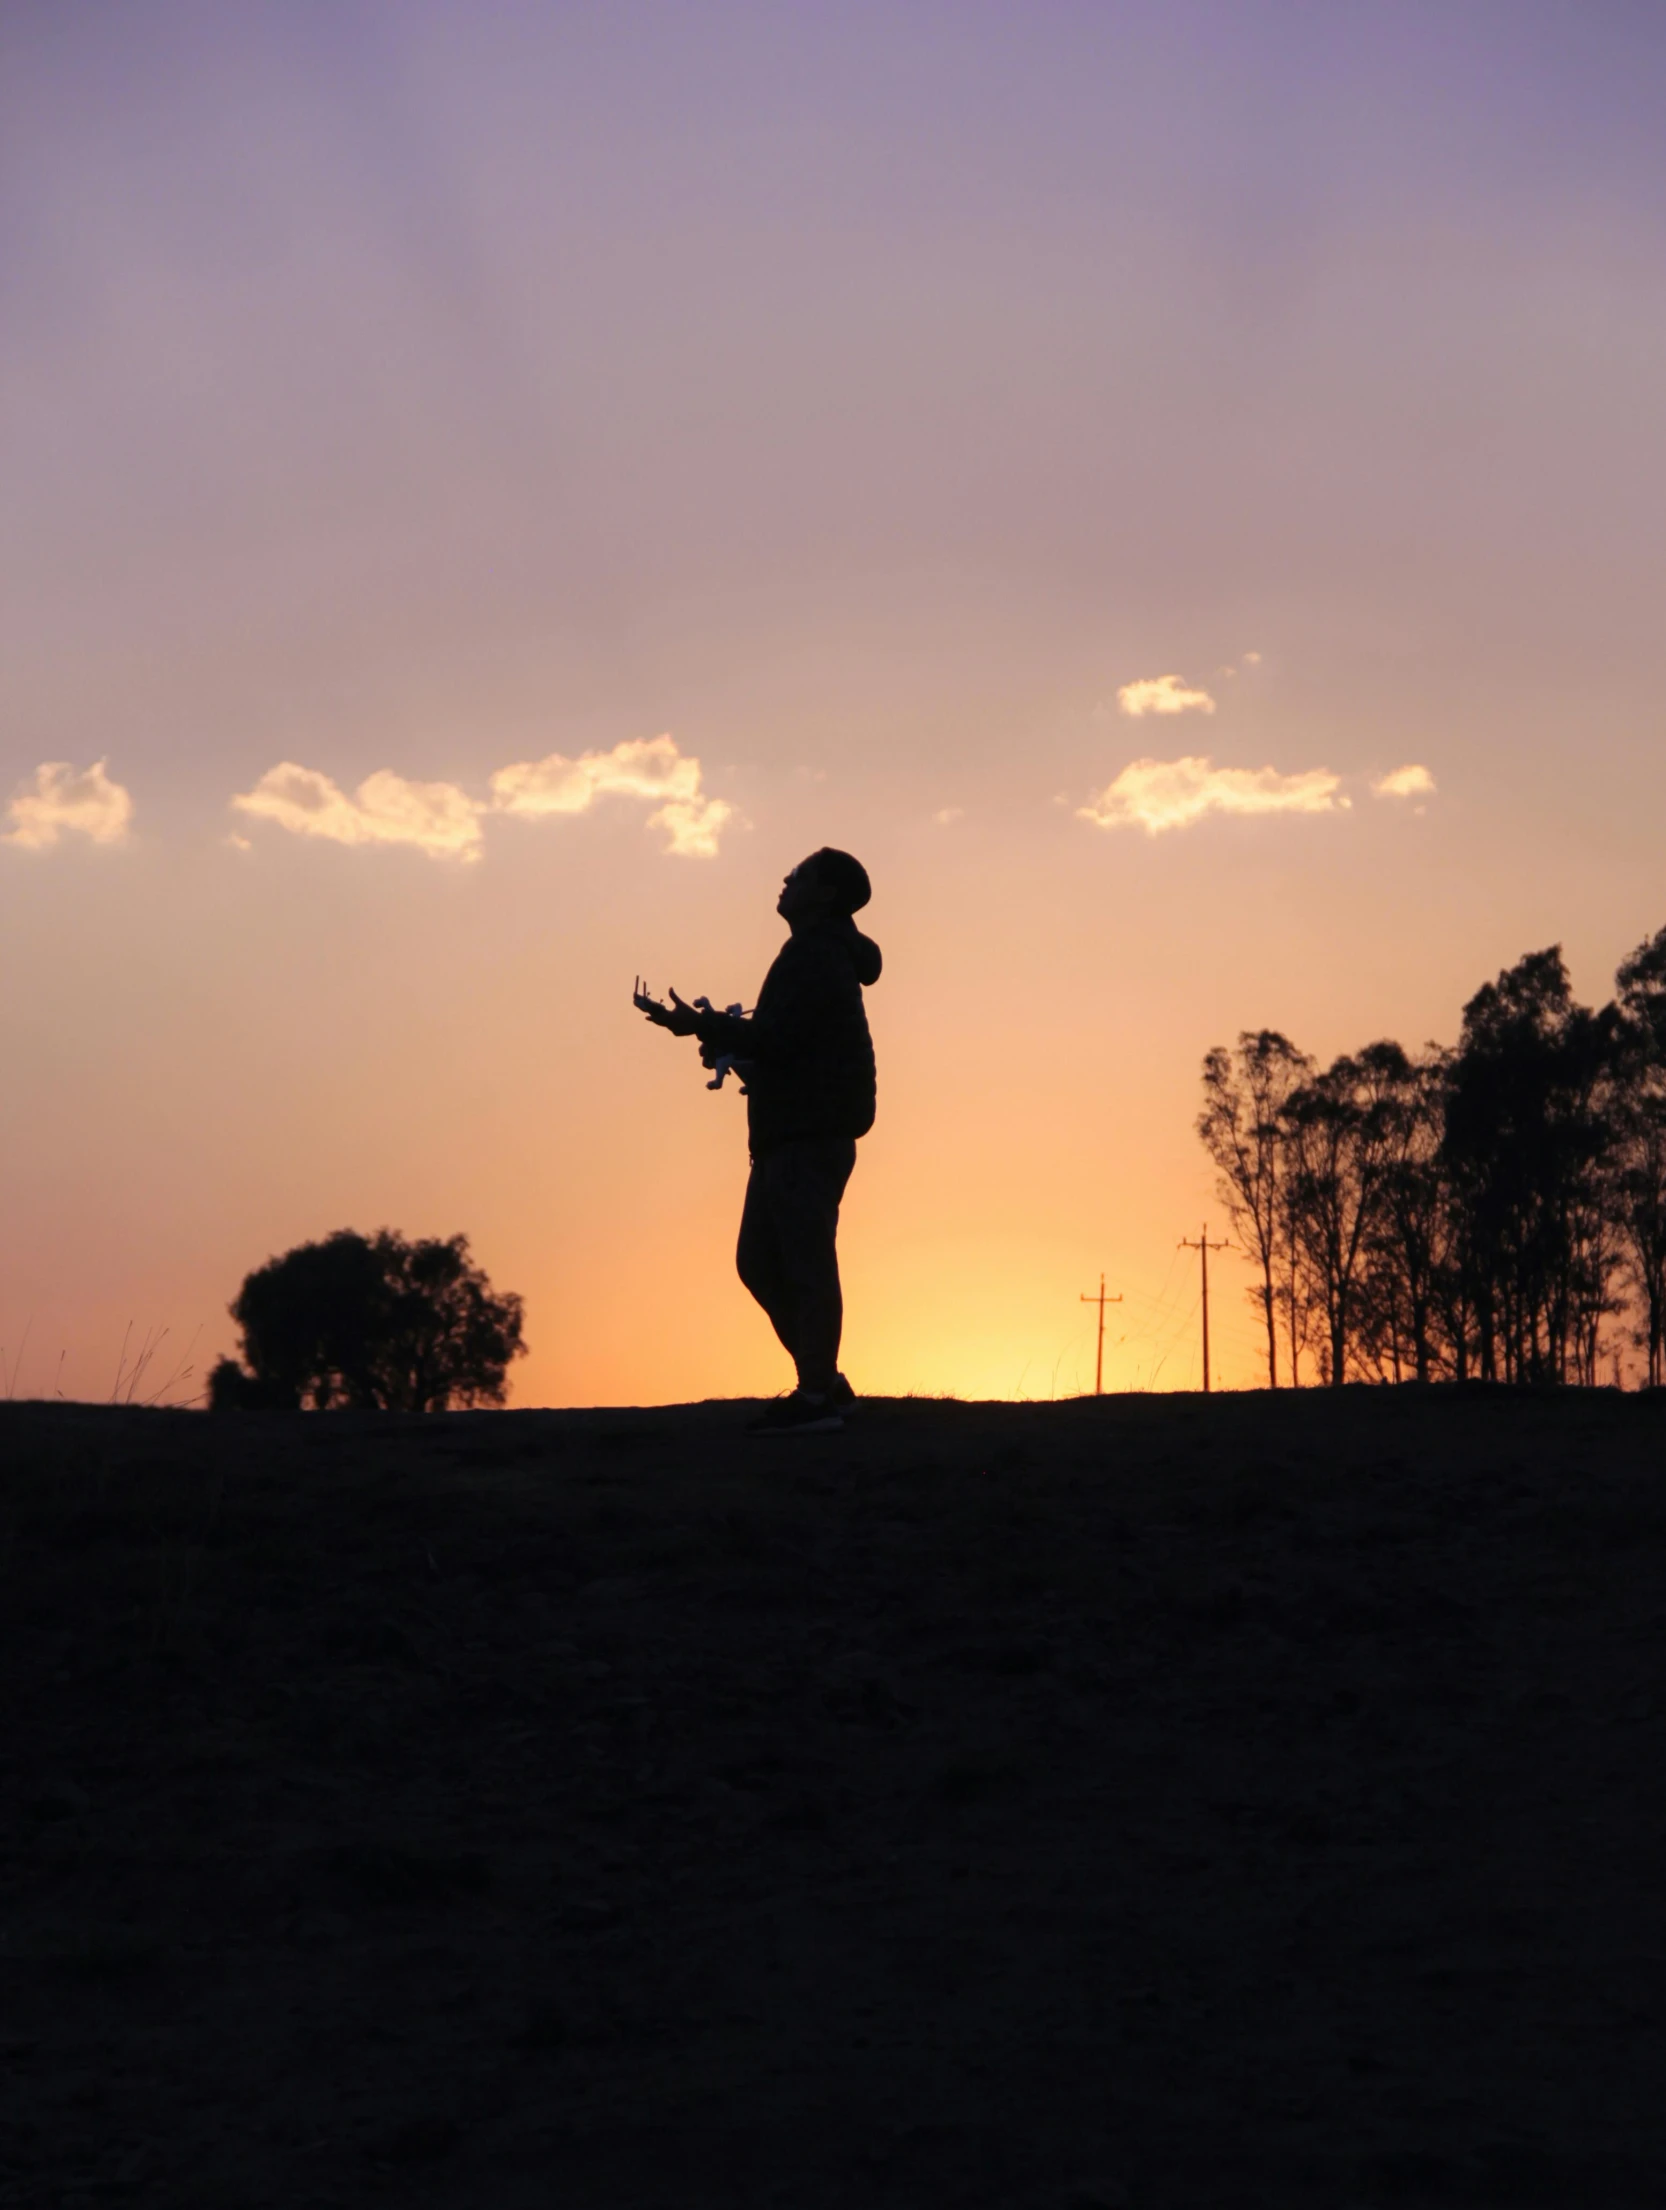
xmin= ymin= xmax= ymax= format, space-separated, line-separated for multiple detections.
xmin=0 ymin=1390 xmax=1666 ymax=2210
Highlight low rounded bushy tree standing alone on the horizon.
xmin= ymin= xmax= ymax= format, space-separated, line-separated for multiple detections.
xmin=210 ymin=1229 xmax=526 ymax=1412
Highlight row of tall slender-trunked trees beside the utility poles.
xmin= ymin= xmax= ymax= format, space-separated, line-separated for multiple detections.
xmin=1198 ymin=928 xmax=1666 ymax=1388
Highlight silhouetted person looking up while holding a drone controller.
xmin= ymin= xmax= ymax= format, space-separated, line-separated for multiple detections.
xmin=636 ymin=846 xmax=879 ymax=1434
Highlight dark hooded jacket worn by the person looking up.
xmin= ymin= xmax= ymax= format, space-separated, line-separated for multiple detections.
xmin=696 ymin=919 xmax=882 ymax=1158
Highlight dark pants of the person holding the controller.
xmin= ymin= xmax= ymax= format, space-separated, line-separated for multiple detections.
xmin=736 ymin=1136 xmax=855 ymax=1392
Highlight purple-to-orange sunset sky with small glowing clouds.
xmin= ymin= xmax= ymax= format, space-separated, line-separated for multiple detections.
xmin=0 ymin=0 xmax=1666 ymax=1403
